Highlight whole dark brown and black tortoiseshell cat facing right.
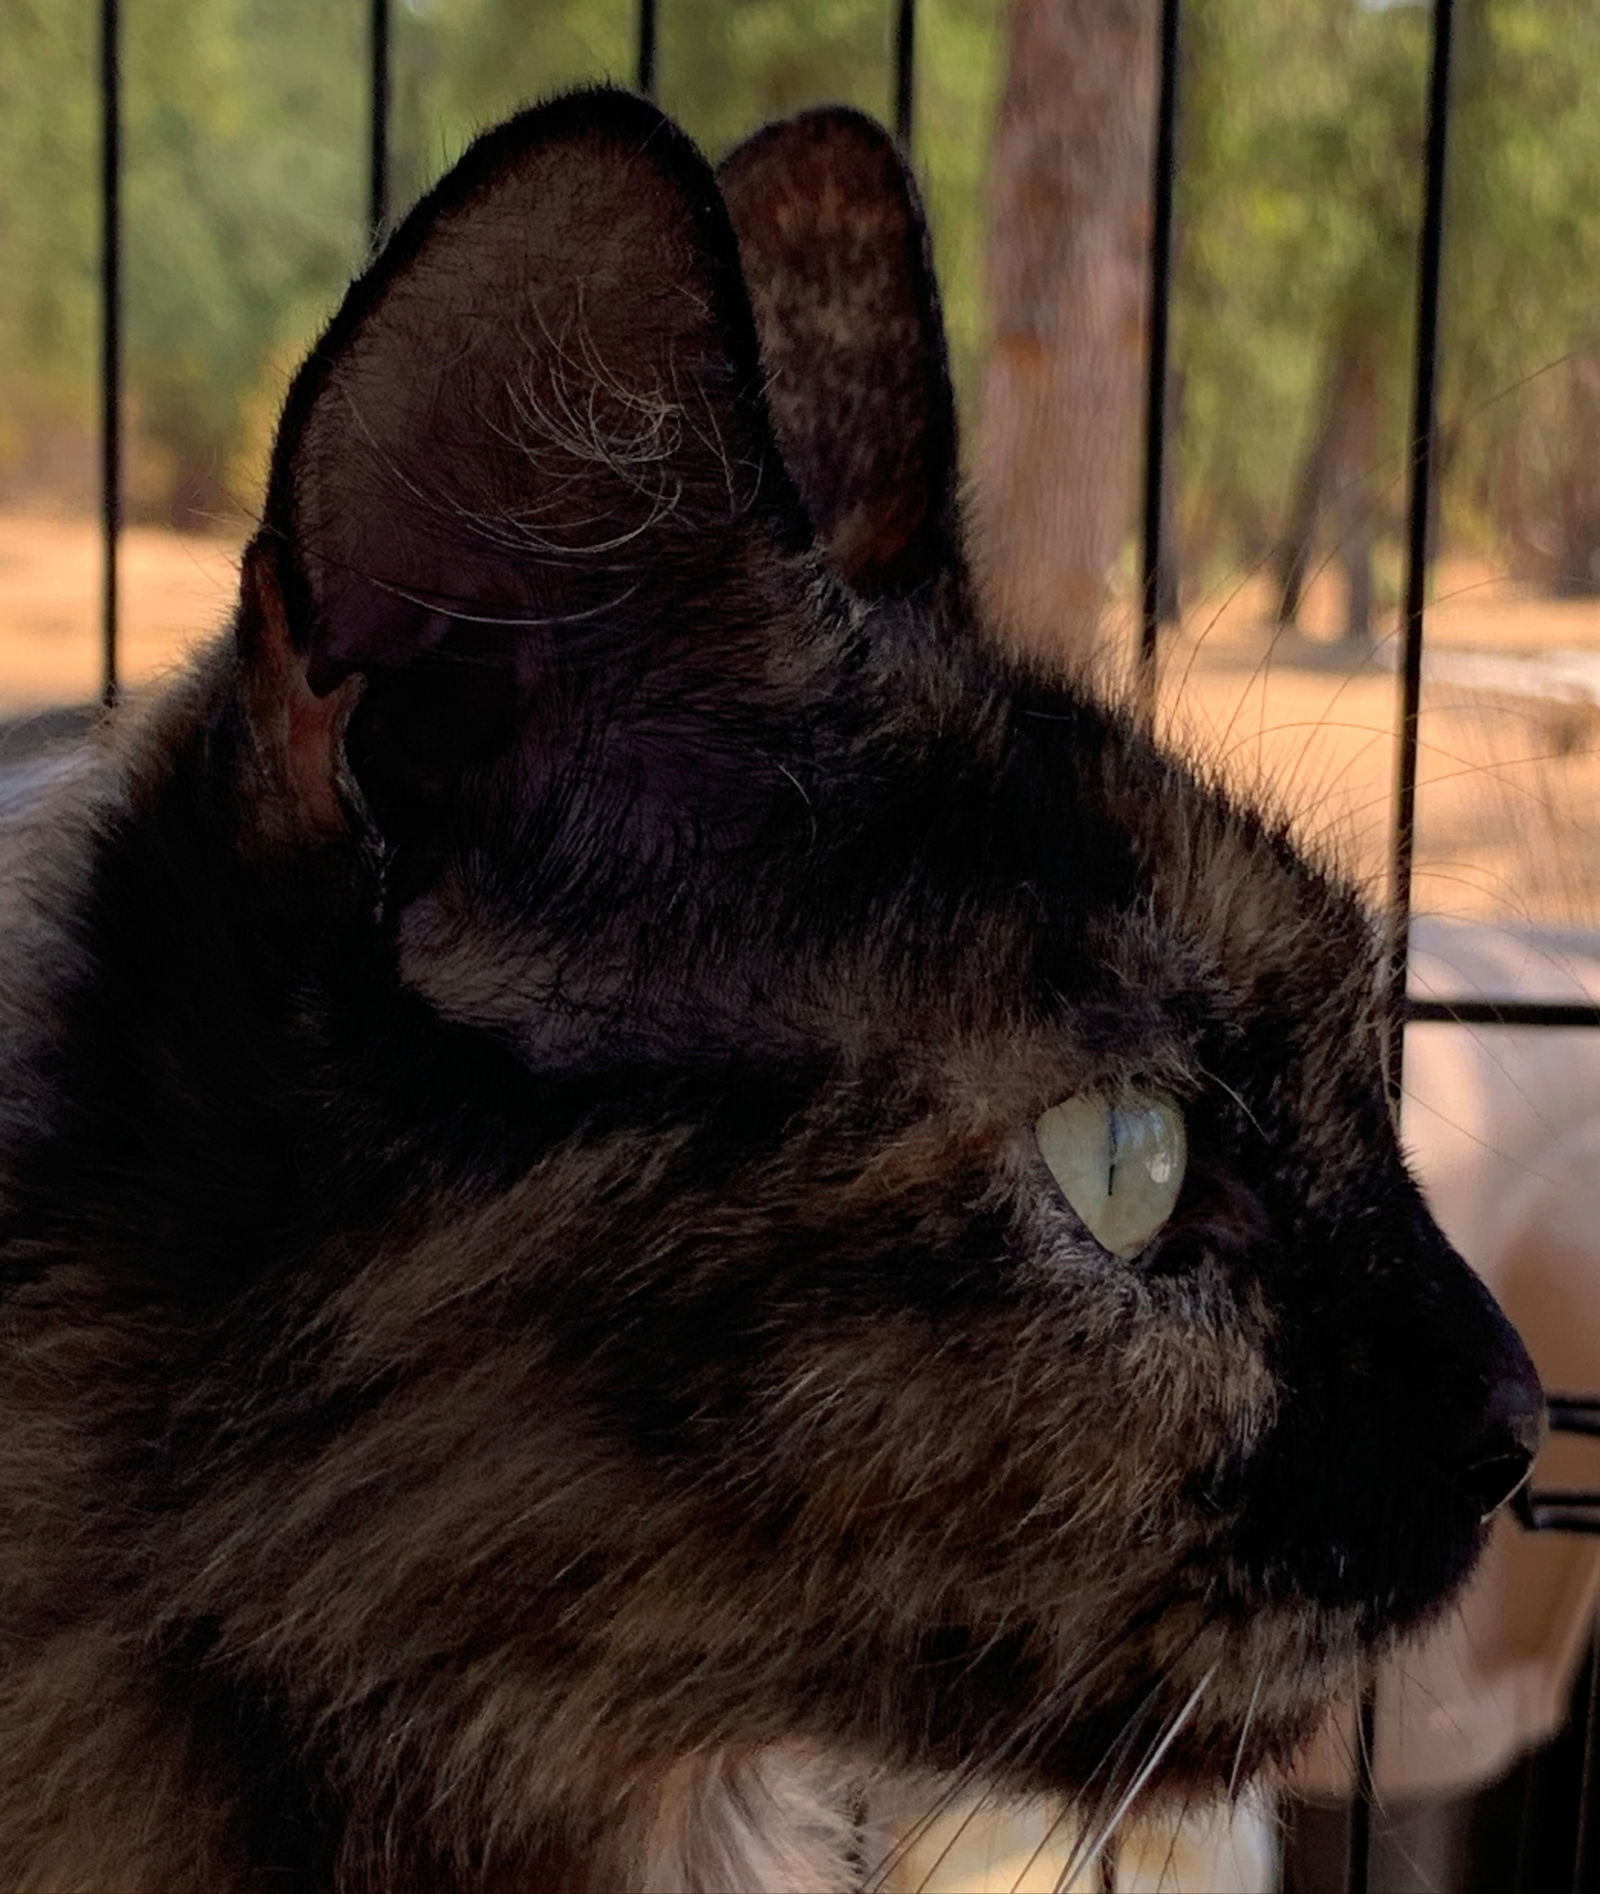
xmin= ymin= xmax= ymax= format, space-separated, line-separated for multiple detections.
xmin=0 ymin=91 xmax=1541 ymax=1894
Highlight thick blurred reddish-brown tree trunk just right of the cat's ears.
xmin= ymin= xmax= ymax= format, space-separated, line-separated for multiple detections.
xmin=971 ymin=0 xmax=1159 ymax=661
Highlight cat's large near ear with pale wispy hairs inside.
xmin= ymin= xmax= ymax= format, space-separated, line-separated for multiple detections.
xmin=265 ymin=91 xmax=810 ymax=693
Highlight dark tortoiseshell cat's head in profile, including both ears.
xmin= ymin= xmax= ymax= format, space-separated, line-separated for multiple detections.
xmin=240 ymin=93 xmax=1541 ymax=1810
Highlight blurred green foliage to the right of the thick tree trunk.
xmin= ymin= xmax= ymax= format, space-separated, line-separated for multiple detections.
xmin=1176 ymin=0 xmax=1600 ymax=587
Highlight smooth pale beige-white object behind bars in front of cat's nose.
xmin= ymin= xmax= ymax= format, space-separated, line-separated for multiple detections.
xmin=1305 ymin=919 xmax=1600 ymax=1797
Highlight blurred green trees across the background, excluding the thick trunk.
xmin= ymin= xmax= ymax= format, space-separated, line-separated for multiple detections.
xmin=0 ymin=0 xmax=1600 ymax=609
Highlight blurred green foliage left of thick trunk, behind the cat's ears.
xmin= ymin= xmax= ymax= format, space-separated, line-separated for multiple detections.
xmin=0 ymin=0 xmax=1002 ymax=523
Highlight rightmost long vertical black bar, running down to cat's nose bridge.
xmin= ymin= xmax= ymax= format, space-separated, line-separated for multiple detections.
xmin=1388 ymin=0 xmax=1454 ymax=1068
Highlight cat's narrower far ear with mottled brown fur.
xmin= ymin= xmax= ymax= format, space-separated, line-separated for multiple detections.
xmin=718 ymin=106 xmax=960 ymax=597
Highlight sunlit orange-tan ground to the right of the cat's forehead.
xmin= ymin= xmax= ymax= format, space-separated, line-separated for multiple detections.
xmin=1163 ymin=559 xmax=1600 ymax=926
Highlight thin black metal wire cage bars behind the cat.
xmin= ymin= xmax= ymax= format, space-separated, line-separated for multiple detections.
xmin=80 ymin=0 xmax=1600 ymax=1894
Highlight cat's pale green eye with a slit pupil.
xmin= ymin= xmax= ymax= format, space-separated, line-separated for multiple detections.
xmin=1034 ymin=1091 xmax=1187 ymax=1256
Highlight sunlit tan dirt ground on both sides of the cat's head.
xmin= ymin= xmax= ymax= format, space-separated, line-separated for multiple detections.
xmin=0 ymin=515 xmax=1600 ymax=928
